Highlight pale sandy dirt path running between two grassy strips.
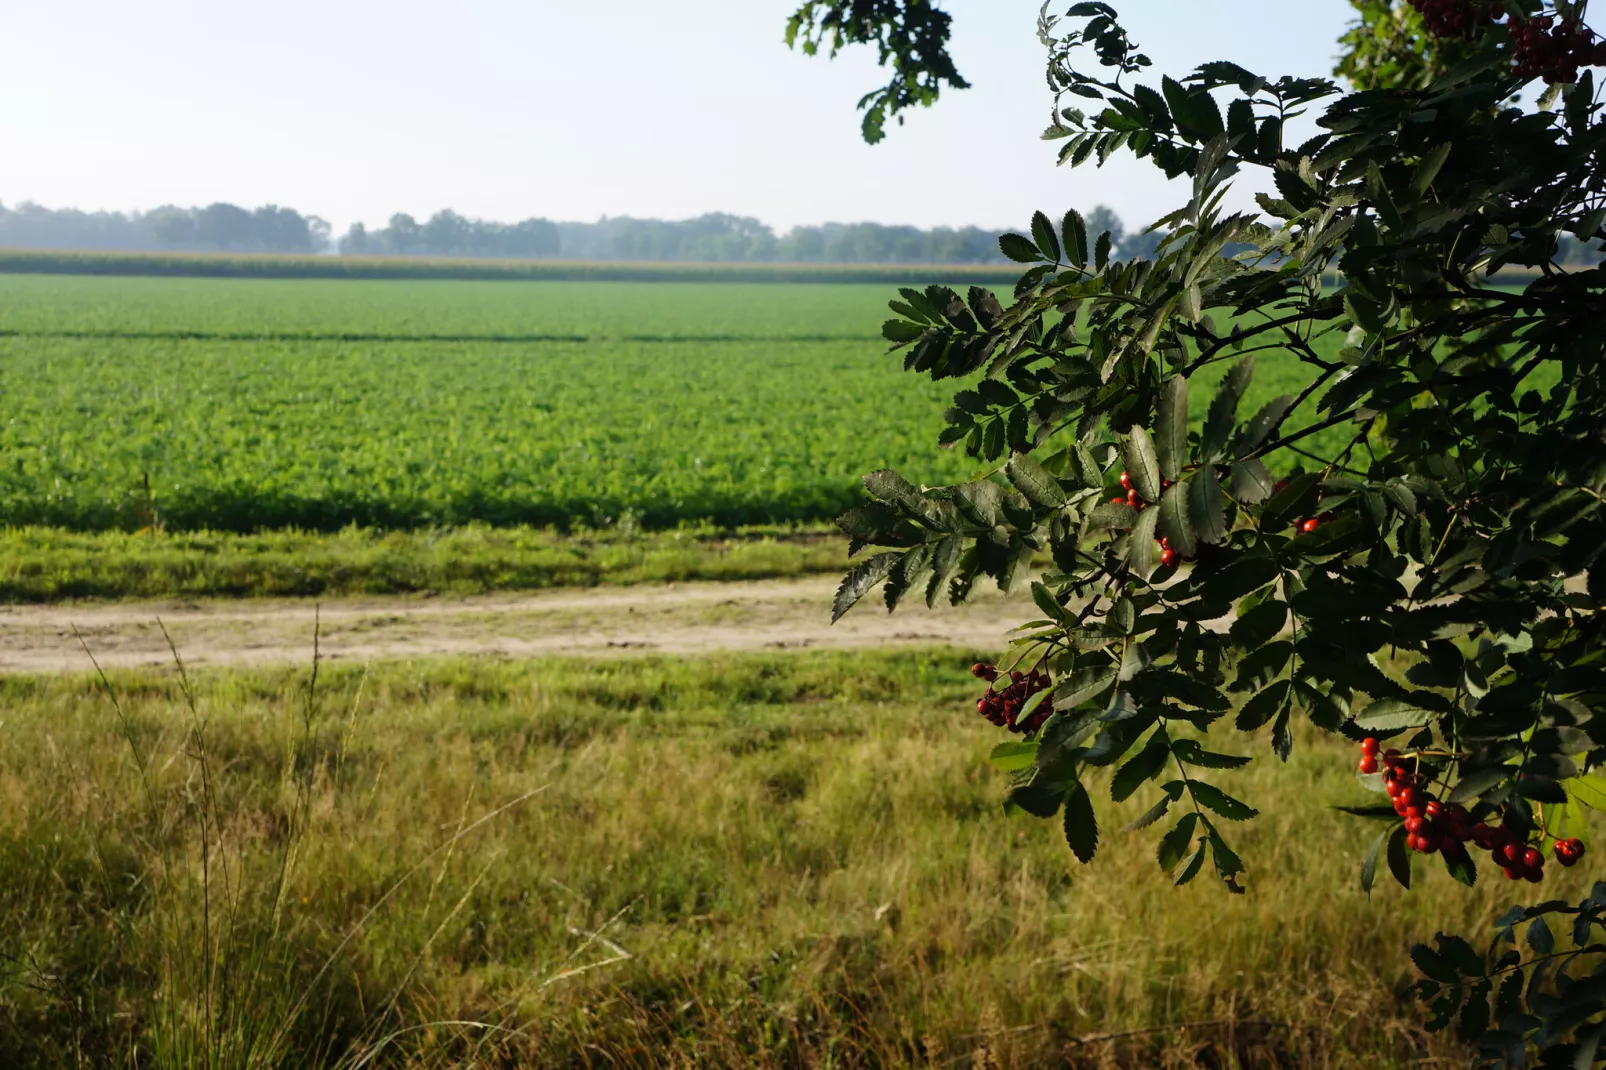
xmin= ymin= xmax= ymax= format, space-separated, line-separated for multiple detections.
xmin=0 ymin=577 xmax=1031 ymax=673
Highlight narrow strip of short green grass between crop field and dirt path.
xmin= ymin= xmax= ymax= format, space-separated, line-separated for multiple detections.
xmin=0 ymin=525 xmax=848 ymax=602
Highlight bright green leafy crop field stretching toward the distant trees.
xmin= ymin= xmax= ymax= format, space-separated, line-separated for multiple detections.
xmin=0 ymin=275 xmax=1323 ymax=532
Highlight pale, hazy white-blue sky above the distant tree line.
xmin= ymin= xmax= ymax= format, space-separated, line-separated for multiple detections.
xmin=0 ymin=0 xmax=1351 ymax=233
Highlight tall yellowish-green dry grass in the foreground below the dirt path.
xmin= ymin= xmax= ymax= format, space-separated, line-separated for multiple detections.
xmin=0 ymin=652 xmax=1587 ymax=1068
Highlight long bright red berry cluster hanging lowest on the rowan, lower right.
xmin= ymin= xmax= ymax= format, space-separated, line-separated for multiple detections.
xmin=1360 ymin=737 xmax=1584 ymax=884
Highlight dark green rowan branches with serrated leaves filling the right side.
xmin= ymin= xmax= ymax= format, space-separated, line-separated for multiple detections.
xmin=803 ymin=3 xmax=1606 ymax=1067
